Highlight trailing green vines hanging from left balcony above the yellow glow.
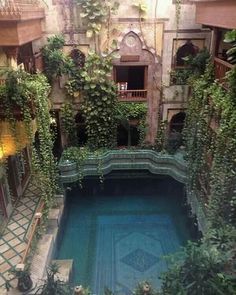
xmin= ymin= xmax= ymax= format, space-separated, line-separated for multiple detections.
xmin=0 ymin=70 xmax=56 ymax=212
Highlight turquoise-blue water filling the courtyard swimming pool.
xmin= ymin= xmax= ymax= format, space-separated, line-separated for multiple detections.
xmin=56 ymin=178 xmax=190 ymax=295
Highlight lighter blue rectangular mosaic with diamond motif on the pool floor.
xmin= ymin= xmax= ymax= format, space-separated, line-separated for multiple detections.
xmin=93 ymin=214 xmax=180 ymax=295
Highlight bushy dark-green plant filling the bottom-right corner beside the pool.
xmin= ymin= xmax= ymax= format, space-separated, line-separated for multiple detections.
xmin=159 ymin=243 xmax=235 ymax=295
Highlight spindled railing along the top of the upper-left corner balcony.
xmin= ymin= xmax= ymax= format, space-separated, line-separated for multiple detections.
xmin=0 ymin=0 xmax=44 ymax=21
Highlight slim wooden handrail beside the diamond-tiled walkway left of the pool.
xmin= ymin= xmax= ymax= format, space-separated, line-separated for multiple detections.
xmin=21 ymin=201 xmax=44 ymax=264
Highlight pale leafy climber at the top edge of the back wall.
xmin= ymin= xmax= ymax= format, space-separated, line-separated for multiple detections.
xmin=77 ymin=0 xmax=119 ymax=37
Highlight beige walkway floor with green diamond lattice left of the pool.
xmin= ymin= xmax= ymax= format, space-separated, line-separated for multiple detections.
xmin=0 ymin=182 xmax=40 ymax=294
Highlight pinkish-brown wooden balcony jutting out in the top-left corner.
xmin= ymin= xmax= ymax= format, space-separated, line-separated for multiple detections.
xmin=0 ymin=0 xmax=45 ymax=46
